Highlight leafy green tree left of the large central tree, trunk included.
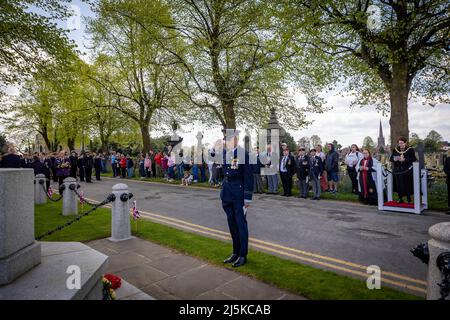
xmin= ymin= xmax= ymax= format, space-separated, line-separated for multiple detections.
xmin=88 ymin=0 xmax=185 ymax=151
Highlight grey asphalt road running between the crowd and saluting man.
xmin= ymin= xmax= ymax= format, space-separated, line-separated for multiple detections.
xmin=72 ymin=178 xmax=450 ymax=294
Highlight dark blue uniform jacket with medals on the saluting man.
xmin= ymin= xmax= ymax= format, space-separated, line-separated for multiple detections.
xmin=220 ymin=148 xmax=253 ymax=202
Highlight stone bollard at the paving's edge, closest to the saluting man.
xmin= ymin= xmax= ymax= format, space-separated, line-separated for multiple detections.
xmin=109 ymin=183 xmax=132 ymax=242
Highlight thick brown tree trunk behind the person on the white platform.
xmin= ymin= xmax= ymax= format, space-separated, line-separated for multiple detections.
xmin=389 ymin=63 xmax=409 ymax=150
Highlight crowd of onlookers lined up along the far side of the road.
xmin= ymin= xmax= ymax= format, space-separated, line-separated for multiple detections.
xmin=0 ymin=137 xmax=450 ymax=212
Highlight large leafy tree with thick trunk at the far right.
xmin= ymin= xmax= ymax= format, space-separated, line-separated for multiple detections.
xmin=283 ymin=0 xmax=450 ymax=147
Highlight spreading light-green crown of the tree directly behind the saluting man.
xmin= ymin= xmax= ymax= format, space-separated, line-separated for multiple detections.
xmin=134 ymin=0 xmax=320 ymax=128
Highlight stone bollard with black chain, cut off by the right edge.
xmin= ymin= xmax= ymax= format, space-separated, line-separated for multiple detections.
xmin=427 ymin=222 xmax=450 ymax=300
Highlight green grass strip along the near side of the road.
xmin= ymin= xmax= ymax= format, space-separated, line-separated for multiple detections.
xmin=35 ymin=202 xmax=421 ymax=300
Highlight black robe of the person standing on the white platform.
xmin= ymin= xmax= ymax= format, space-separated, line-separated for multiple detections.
xmin=389 ymin=148 xmax=417 ymax=197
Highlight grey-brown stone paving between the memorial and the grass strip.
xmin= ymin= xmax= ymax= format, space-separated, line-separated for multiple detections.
xmin=87 ymin=238 xmax=303 ymax=300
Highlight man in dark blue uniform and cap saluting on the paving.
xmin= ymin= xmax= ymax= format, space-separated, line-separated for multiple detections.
xmin=220 ymin=130 xmax=253 ymax=267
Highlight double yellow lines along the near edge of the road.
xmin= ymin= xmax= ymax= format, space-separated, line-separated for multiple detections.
xmin=86 ymin=198 xmax=426 ymax=293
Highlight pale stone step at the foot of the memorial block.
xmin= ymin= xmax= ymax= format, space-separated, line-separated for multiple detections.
xmin=0 ymin=242 xmax=108 ymax=300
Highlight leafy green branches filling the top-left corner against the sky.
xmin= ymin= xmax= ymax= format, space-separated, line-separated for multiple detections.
xmin=0 ymin=0 xmax=74 ymax=92
